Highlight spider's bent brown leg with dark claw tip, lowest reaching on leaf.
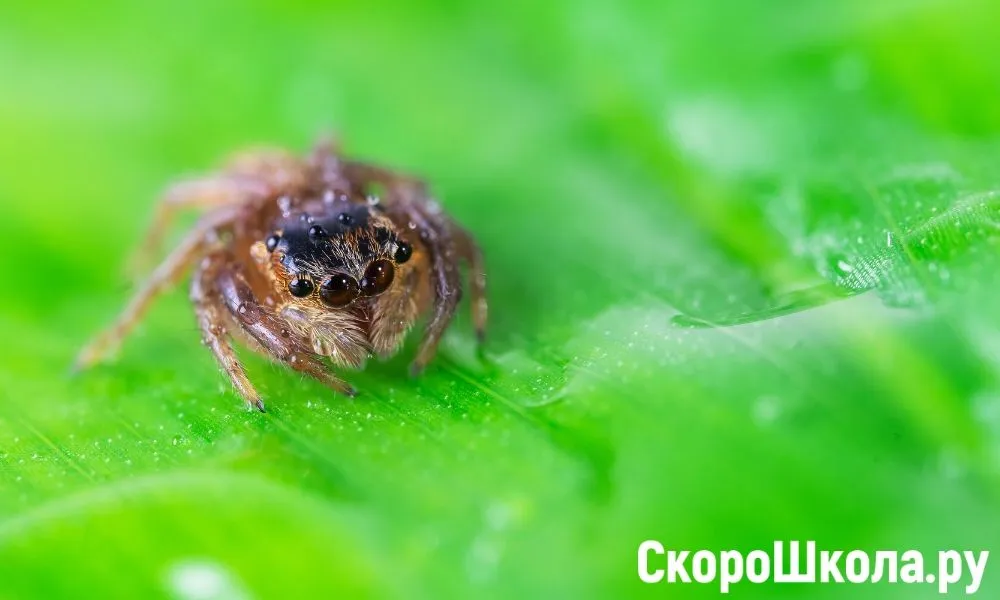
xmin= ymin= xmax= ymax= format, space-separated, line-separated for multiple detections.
xmin=191 ymin=254 xmax=264 ymax=412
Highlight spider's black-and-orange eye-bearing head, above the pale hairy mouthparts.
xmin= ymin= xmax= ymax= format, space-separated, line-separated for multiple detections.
xmin=258 ymin=202 xmax=413 ymax=309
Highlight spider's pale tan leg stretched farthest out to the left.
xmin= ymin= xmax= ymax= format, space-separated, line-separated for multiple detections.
xmin=74 ymin=209 xmax=235 ymax=371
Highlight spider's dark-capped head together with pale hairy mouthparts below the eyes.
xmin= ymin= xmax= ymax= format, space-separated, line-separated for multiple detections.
xmin=252 ymin=193 xmax=430 ymax=367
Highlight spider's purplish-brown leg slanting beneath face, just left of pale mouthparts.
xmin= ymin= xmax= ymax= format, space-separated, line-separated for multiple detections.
xmin=215 ymin=261 xmax=357 ymax=397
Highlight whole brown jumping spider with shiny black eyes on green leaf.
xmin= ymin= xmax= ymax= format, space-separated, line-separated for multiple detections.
xmin=76 ymin=142 xmax=487 ymax=411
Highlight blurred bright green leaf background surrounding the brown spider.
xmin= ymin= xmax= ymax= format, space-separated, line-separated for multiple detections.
xmin=0 ymin=0 xmax=1000 ymax=599
